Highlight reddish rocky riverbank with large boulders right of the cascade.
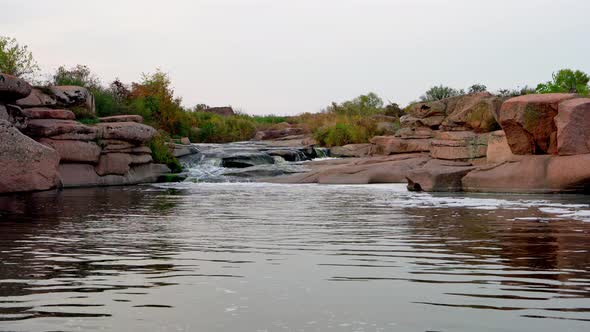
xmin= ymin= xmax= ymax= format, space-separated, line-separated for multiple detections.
xmin=265 ymin=93 xmax=590 ymax=193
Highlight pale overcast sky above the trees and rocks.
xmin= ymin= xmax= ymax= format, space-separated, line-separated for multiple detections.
xmin=0 ymin=0 xmax=590 ymax=114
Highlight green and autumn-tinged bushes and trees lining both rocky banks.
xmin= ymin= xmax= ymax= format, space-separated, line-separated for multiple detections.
xmin=0 ymin=37 xmax=590 ymax=150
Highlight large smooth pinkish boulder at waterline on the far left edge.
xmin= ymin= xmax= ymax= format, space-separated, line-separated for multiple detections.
xmin=0 ymin=120 xmax=59 ymax=193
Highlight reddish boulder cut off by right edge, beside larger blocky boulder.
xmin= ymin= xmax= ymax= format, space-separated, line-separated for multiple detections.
xmin=555 ymin=98 xmax=590 ymax=156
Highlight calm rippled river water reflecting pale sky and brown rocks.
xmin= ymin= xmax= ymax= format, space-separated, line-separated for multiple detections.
xmin=0 ymin=184 xmax=590 ymax=331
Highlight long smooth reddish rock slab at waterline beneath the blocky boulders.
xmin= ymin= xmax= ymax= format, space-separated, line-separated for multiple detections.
xmin=462 ymin=154 xmax=590 ymax=193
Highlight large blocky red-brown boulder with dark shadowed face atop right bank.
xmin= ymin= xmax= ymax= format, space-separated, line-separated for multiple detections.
xmin=498 ymin=93 xmax=576 ymax=155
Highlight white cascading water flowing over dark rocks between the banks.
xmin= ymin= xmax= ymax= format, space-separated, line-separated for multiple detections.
xmin=180 ymin=142 xmax=329 ymax=182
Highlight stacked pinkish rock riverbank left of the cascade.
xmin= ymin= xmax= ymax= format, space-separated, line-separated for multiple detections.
xmin=0 ymin=74 xmax=170 ymax=194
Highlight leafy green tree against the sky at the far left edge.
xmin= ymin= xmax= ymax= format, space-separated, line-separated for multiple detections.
xmin=0 ymin=36 xmax=39 ymax=78
